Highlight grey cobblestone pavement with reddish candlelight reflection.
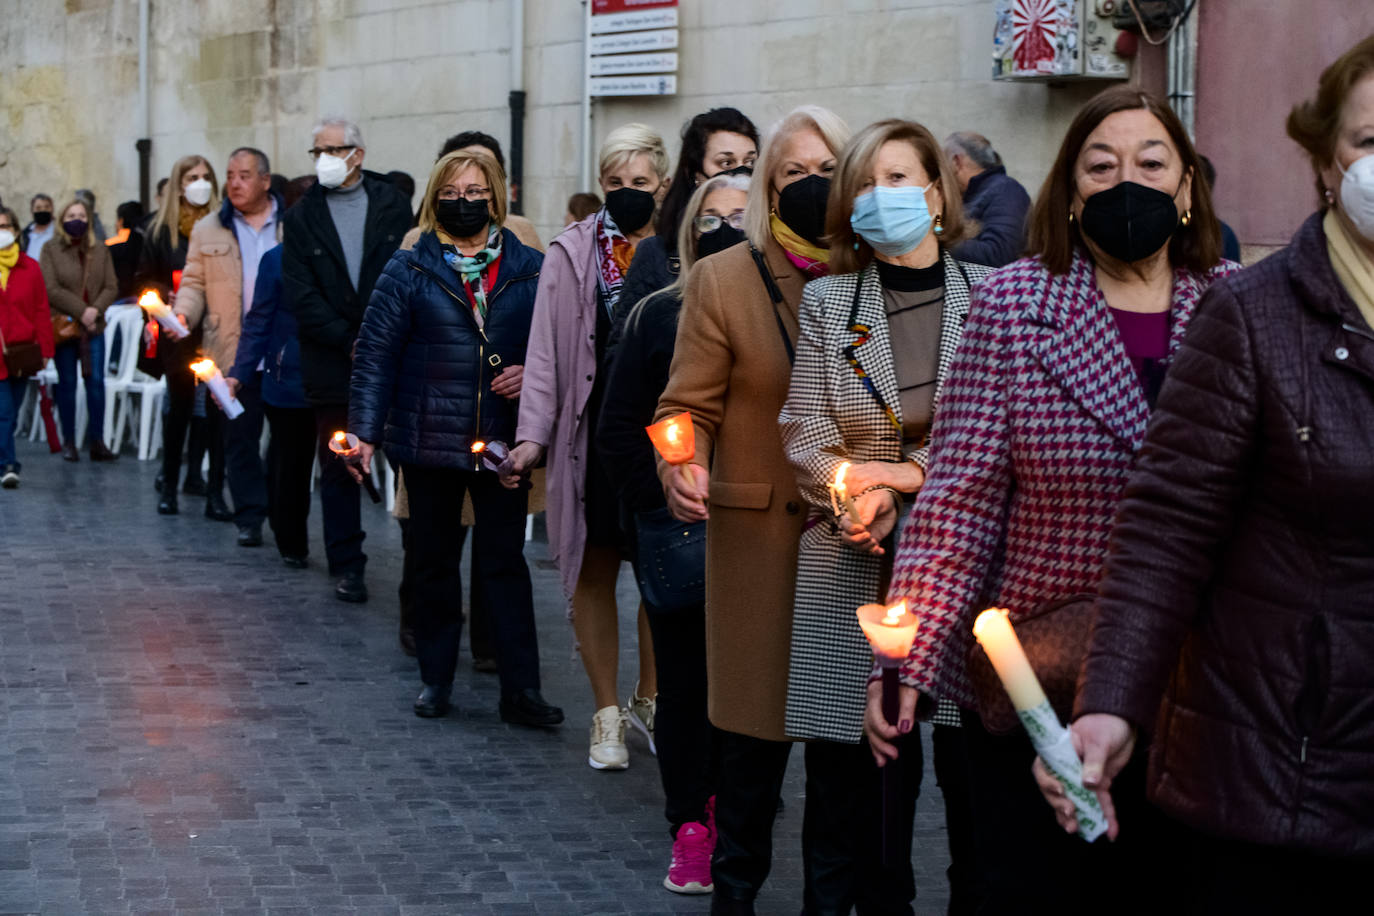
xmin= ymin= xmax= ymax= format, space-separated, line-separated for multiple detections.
xmin=0 ymin=442 xmax=947 ymax=915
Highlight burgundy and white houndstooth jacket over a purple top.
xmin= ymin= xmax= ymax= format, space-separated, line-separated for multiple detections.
xmin=888 ymin=253 xmax=1237 ymax=709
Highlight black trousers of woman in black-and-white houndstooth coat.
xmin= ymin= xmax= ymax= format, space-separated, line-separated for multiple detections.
xmin=801 ymin=729 xmax=922 ymax=916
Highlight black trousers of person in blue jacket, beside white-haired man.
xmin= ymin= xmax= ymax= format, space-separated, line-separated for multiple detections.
xmin=262 ymin=404 xmax=315 ymax=558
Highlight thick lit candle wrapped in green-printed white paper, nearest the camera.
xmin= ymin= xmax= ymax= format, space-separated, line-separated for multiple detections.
xmin=973 ymin=607 xmax=1107 ymax=843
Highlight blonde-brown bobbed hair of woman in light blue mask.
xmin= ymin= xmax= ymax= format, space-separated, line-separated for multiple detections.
xmin=826 ymin=118 xmax=969 ymax=273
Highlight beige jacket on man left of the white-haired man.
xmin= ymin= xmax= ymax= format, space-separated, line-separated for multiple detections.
xmin=177 ymin=211 xmax=282 ymax=374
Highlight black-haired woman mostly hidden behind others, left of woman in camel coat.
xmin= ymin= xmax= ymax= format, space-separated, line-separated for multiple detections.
xmin=614 ymin=108 xmax=758 ymax=318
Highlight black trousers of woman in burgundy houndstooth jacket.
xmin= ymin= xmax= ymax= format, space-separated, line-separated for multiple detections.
xmin=960 ymin=711 xmax=1170 ymax=915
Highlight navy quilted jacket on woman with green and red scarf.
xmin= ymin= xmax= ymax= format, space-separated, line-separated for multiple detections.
xmin=348 ymin=229 xmax=544 ymax=471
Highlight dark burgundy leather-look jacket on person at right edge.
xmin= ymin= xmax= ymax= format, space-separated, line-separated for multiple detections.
xmin=1076 ymin=216 xmax=1374 ymax=857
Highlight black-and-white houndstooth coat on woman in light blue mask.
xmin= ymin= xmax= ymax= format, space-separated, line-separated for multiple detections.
xmin=778 ymin=253 xmax=991 ymax=743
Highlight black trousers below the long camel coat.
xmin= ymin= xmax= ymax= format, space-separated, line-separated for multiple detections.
xmin=710 ymin=731 xmax=791 ymax=900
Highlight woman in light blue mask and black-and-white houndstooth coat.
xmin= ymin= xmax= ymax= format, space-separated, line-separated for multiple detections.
xmin=778 ymin=119 xmax=991 ymax=912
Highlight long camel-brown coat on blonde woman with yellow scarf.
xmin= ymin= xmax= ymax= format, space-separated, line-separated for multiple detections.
xmin=655 ymin=239 xmax=807 ymax=740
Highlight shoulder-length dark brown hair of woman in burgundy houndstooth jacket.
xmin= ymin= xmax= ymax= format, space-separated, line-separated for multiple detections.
xmin=1026 ymin=85 xmax=1221 ymax=273
